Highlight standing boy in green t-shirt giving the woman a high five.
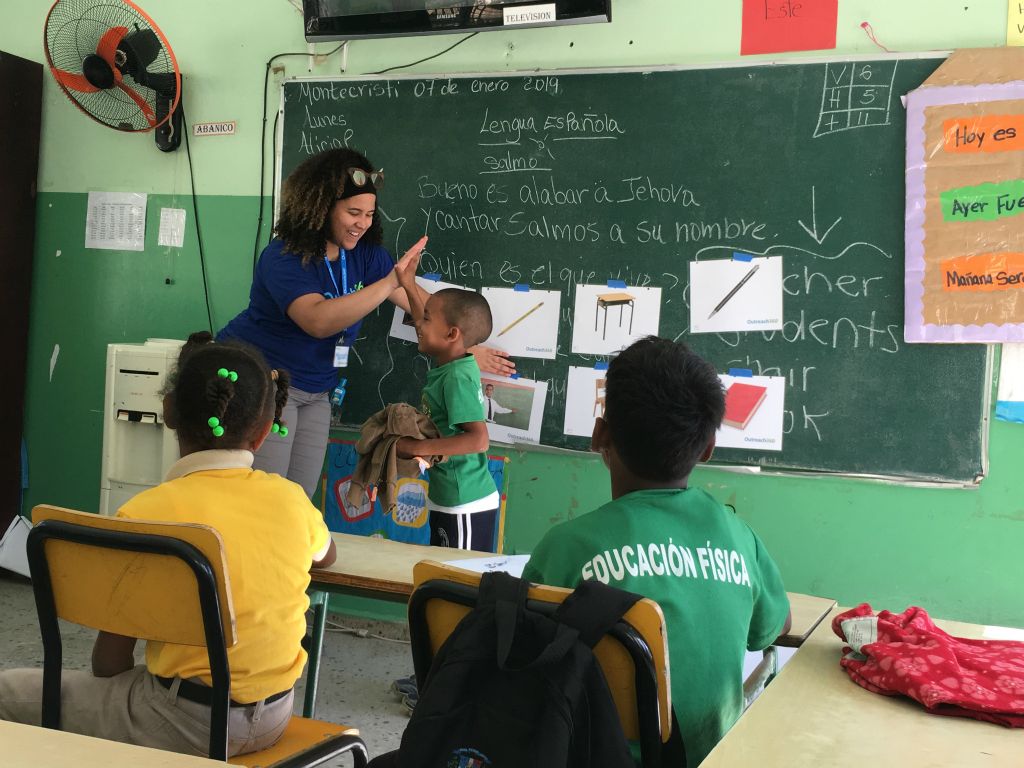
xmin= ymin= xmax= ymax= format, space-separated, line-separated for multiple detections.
xmin=395 ymin=265 xmax=501 ymax=552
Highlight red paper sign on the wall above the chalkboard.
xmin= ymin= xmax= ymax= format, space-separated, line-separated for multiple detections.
xmin=739 ymin=0 xmax=839 ymax=56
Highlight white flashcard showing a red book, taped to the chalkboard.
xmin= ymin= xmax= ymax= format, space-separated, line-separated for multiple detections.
xmin=715 ymin=374 xmax=785 ymax=451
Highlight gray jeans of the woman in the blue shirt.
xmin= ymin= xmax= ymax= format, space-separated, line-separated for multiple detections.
xmin=253 ymin=387 xmax=331 ymax=499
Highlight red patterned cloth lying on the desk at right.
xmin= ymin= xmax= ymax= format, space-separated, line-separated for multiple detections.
xmin=833 ymin=603 xmax=1024 ymax=728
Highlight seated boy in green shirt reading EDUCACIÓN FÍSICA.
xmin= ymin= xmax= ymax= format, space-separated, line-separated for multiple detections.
xmin=523 ymin=336 xmax=791 ymax=768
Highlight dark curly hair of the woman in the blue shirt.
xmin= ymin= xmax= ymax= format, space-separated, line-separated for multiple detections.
xmin=273 ymin=147 xmax=384 ymax=264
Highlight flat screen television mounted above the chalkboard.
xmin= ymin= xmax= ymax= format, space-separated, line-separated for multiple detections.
xmin=302 ymin=0 xmax=611 ymax=43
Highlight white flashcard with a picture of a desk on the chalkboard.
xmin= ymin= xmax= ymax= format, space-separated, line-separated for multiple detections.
xmin=572 ymin=282 xmax=662 ymax=354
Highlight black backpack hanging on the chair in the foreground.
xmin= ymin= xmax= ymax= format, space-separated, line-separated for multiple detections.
xmin=396 ymin=572 xmax=685 ymax=768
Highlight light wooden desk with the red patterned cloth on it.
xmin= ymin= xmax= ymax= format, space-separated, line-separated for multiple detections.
xmin=700 ymin=608 xmax=1024 ymax=768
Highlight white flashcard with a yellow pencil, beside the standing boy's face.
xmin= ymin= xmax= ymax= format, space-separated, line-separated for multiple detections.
xmin=480 ymin=286 xmax=562 ymax=360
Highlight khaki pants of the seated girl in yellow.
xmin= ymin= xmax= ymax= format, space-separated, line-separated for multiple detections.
xmin=0 ymin=666 xmax=295 ymax=757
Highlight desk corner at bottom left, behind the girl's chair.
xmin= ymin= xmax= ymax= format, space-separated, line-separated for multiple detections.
xmin=0 ymin=720 xmax=225 ymax=768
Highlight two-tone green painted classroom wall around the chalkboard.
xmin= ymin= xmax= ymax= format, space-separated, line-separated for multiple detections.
xmin=8 ymin=0 xmax=1024 ymax=627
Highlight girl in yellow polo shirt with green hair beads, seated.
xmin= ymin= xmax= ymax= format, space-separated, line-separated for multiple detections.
xmin=0 ymin=334 xmax=335 ymax=755
